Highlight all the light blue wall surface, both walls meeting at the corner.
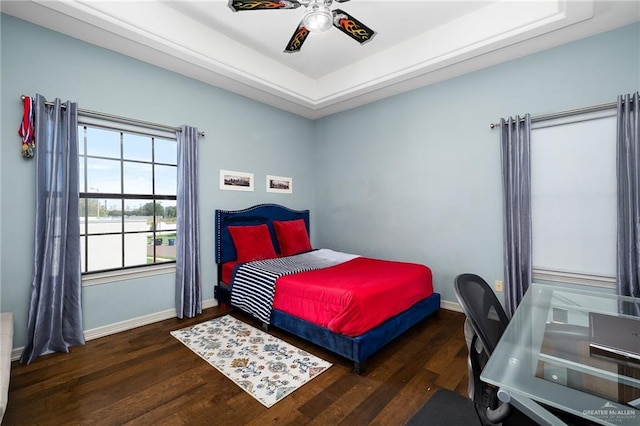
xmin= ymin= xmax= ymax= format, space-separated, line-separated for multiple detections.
xmin=0 ymin=11 xmax=640 ymax=347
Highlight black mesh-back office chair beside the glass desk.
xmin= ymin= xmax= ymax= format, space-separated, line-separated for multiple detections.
xmin=454 ymin=274 xmax=536 ymax=425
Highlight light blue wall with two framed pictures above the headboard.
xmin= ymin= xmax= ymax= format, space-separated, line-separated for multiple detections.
xmin=0 ymin=14 xmax=315 ymax=347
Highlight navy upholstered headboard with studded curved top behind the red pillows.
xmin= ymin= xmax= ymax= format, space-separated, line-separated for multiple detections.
xmin=215 ymin=204 xmax=310 ymax=264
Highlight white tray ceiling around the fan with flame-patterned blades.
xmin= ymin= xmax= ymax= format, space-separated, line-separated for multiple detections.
xmin=0 ymin=0 xmax=640 ymax=119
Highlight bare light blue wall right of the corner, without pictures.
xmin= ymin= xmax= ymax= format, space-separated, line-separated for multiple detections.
xmin=314 ymin=24 xmax=640 ymax=301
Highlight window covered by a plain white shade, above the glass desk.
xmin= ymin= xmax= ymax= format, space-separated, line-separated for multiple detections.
xmin=531 ymin=109 xmax=617 ymax=287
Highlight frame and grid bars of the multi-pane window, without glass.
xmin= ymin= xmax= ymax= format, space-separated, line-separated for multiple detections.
xmin=76 ymin=114 xmax=179 ymax=286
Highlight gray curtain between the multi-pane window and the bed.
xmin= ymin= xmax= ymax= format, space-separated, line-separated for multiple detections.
xmin=176 ymin=126 xmax=202 ymax=318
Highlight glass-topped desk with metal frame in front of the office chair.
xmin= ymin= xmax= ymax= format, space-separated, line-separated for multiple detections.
xmin=480 ymin=284 xmax=640 ymax=425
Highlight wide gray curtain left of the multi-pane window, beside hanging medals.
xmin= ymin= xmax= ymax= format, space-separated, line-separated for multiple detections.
xmin=20 ymin=95 xmax=84 ymax=364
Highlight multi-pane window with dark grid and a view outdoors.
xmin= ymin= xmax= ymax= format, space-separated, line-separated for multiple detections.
xmin=78 ymin=117 xmax=179 ymax=274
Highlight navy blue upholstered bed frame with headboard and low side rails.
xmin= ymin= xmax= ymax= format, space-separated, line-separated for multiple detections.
xmin=214 ymin=204 xmax=440 ymax=373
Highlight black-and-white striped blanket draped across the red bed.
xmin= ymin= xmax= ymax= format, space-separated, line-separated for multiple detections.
xmin=231 ymin=249 xmax=358 ymax=324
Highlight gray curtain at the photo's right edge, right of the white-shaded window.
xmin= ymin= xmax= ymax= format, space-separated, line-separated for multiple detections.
xmin=616 ymin=92 xmax=640 ymax=297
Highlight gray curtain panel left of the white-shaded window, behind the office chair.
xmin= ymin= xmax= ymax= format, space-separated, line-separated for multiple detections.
xmin=500 ymin=114 xmax=532 ymax=316
